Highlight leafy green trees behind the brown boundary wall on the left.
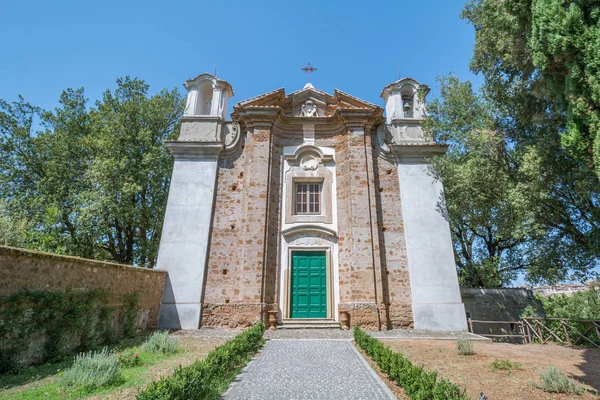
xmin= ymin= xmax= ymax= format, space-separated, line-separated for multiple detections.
xmin=0 ymin=77 xmax=183 ymax=267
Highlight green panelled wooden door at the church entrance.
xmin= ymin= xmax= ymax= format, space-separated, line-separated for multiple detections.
xmin=291 ymin=251 xmax=327 ymax=318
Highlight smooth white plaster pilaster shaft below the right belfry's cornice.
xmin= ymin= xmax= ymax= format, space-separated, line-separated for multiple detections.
xmin=398 ymin=160 xmax=467 ymax=331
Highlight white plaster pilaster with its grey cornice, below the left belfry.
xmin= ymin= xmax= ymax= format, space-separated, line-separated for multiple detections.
xmin=157 ymin=142 xmax=221 ymax=329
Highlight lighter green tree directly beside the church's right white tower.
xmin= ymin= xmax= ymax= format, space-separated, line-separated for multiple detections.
xmin=424 ymin=76 xmax=541 ymax=287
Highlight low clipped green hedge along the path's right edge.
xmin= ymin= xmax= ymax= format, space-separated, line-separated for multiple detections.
xmin=354 ymin=327 xmax=469 ymax=400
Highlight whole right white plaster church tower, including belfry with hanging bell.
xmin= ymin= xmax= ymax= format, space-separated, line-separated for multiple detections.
xmin=377 ymin=78 xmax=467 ymax=331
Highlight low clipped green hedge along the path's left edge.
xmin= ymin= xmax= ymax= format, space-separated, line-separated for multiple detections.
xmin=137 ymin=323 xmax=265 ymax=400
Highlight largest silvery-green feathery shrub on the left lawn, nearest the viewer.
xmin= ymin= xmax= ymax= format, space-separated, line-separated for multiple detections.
xmin=58 ymin=347 xmax=121 ymax=390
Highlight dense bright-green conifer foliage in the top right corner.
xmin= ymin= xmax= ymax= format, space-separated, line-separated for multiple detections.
xmin=528 ymin=0 xmax=600 ymax=176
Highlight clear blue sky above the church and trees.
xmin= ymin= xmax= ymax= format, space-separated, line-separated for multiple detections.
xmin=0 ymin=0 xmax=480 ymax=109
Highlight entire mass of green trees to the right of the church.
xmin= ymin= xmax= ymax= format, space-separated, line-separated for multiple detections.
xmin=425 ymin=0 xmax=600 ymax=287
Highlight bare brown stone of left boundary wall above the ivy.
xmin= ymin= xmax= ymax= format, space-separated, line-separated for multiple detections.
xmin=0 ymin=246 xmax=167 ymax=329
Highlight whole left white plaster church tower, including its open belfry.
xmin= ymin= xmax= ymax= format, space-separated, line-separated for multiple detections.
xmin=157 ymin=74 xmax=234 ymax=329
